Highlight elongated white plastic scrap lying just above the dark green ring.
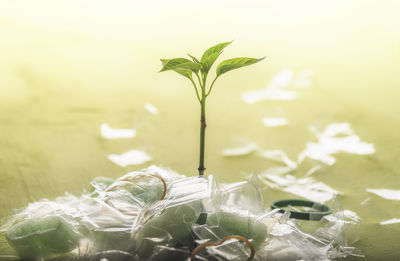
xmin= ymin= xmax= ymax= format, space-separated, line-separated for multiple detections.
xmin=260 ymin=174 xmax=340 ymax=204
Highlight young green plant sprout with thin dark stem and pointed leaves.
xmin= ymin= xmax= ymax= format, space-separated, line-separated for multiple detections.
xmin=160 ymin=42 xmax=265 ymax=176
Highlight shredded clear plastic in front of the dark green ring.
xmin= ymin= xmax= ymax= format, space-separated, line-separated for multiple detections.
xmin=256 ymin=199 xmax=363 ymax=261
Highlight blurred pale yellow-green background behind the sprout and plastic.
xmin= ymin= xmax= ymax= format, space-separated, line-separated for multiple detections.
xmin=0 ymin=0 xmax=400 ymax=260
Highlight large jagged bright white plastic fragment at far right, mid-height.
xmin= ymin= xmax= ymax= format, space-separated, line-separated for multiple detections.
xmin=298 ymin=123 xmax=375 ymax=165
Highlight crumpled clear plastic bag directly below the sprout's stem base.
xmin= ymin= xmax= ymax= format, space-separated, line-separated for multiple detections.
xmin=132 ymin=176 xmax=220 ymax=260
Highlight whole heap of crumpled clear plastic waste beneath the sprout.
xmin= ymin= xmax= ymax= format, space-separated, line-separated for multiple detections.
xmin=2 ymin=166 xmax=357 ymax=261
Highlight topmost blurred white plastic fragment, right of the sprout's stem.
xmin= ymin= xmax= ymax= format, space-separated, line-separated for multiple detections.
xmin=242 ymin=69 xmax=298 ymax=103
